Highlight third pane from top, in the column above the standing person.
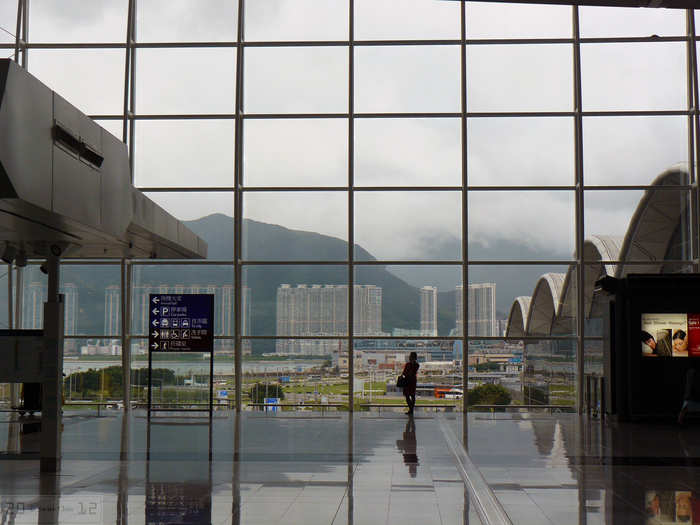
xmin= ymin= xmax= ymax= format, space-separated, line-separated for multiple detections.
xmin=355 ymin=118 xmax=462 ymax=186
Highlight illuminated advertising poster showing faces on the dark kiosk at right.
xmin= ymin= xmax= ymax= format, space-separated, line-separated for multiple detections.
xmin=641 ymin=313 xmax=700 ymax=357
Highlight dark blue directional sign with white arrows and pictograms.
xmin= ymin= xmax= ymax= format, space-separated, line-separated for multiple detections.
xmin=148 ymin=294 xmax=214 ymax=352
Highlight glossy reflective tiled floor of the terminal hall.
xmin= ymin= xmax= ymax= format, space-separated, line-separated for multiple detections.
xmin=0 ymin=411 xmax=700 ymax=525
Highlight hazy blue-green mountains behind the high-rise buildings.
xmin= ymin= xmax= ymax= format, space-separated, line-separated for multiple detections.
xmin=20 ymin=214 xmax=562 ymax=352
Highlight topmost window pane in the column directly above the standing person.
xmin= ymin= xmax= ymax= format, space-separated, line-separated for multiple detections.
xmin=355 ymin=0 xmax=460 ymax=40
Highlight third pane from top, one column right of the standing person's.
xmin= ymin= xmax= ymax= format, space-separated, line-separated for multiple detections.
xmin=467 ymin=117 xmax=574 ymax=186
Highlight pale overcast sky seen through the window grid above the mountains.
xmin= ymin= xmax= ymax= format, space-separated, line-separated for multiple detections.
xmin=0 ymin=0 xmax=687 ymax=259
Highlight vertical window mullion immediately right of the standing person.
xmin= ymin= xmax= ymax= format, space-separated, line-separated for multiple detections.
xmin=459 ymin=2 xmax=469 ymax=414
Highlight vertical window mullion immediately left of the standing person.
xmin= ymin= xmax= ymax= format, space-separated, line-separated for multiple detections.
xmin=346 ymin=0 xmax=355 ymax=412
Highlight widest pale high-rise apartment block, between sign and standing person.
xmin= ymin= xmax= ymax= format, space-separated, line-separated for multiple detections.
xmin=276 ymin=284 xmax=382 ymax=355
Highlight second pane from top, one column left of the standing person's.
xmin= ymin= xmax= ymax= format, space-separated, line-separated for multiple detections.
xmin=245 ymin=47 xmax=348 ymax=113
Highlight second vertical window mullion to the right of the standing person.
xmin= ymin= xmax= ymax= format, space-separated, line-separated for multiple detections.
xmin=571 ymin=5 xmax=585 ymax=414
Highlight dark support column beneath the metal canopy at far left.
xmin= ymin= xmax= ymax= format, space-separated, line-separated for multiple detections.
xmin=41 ymin=255 xmax=63 ymax=472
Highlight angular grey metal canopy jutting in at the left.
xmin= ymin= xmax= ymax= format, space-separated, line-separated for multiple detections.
xmin=0 ymin=59 xmax=207 ymax=259
